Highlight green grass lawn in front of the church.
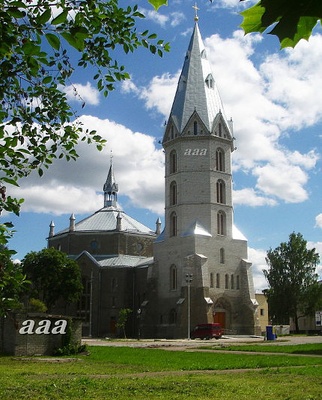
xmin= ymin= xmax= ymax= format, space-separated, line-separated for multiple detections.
xmin=0 ymin=344 xmax=322 ymax=400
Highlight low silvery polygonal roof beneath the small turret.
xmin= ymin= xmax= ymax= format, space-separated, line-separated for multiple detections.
xmin=57 ymin=206 xmax=155 ymax=235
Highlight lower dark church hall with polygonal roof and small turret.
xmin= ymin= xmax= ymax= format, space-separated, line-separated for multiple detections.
xmin=48 ymin=162 xmax=161 ymax=337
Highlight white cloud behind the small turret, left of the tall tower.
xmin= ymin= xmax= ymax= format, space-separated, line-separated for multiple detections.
xmin=10 ymin=115 xmax=164 ymax=215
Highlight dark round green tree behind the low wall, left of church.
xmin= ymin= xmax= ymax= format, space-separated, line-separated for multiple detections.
xmin=22 ymin=247 xmax=83 ymax=311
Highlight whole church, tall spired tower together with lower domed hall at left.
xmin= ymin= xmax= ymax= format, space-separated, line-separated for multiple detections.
xmin=48 ymin=17 xmax=259 ymax=338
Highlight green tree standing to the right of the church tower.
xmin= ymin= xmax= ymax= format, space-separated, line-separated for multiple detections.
xmin=263 ymin=232 xmax=320 ymax=332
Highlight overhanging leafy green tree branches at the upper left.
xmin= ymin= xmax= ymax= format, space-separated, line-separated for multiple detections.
xmin=0 ymin=0 xmax=169 ymax=213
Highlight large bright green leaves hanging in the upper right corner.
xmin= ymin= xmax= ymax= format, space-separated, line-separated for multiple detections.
xmin=240 ymin=0 xmax=322 ymax=48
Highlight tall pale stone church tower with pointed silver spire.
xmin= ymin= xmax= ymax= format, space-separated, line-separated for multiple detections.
xmin=146 ymin=17 xmax=257 ymax=337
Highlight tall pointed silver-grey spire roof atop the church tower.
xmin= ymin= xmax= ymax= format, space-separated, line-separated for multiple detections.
xmin=169 ymin=22 xmax=226 ymax=133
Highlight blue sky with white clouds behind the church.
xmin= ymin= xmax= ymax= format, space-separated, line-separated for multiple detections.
xmin=1 ymin=0 xmax=322 ymax=291
